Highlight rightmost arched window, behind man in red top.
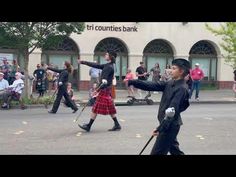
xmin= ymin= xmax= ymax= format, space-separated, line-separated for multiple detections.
xmin=189 ymin=40 xmax=217 ymax=83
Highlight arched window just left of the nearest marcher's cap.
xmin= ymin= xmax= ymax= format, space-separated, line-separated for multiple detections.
xmin=143 ymin=39 xmax=174 ymax=80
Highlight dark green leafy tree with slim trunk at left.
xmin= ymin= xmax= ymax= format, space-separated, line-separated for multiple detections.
xmin=0 ymin=22 xmax=85 ymax=96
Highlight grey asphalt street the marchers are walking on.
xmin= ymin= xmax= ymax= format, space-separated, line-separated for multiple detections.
xmin=0 ymin=104 xmax=236 ymax=155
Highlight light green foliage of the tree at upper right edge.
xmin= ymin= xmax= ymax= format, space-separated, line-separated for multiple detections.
xmin=206 ymin=22 xmax=236 ymax=69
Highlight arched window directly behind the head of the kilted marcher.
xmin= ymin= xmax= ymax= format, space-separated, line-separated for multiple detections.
xmin=94 ymin=38 xmax=128 ymax=89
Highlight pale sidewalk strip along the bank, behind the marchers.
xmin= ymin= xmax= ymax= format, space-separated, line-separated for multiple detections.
xmin=71 ymin=90 xmax=236 ymax=105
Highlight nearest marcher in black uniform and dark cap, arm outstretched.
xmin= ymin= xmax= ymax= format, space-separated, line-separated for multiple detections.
xmin=128 ymin=58 xmax=190 ymax=155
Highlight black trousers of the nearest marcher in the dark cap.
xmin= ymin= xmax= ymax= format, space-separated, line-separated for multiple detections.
xmin=151 ymin=124 xmax=184 ymax=155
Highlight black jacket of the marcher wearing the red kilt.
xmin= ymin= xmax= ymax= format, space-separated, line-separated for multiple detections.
xmin=81 ymin=61 xmax=114 ymax=88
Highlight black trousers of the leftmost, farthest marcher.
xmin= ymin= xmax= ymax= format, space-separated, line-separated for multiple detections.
xmin=52 ymin=85 xmax=78 ymax=112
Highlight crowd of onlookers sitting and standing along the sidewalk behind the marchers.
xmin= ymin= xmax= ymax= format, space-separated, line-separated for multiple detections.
xmin=0 ymin=58 xmax=236 ymax=108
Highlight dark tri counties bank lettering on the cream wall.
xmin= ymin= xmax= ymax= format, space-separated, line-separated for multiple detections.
xmin=86 ymin=24 xmax=138 ymax=32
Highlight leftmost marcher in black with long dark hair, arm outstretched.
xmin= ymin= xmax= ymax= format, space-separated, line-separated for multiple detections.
xmin=47 ymin=61 xmax=78 ymax=114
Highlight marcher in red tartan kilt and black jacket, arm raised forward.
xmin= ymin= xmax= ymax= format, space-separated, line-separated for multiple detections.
xmin=78 ymin=50 xmax=121 ymax=132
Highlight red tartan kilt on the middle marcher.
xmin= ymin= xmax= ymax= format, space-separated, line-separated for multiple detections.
xmin=92 ymin=88 xmax=116 ymax=115
